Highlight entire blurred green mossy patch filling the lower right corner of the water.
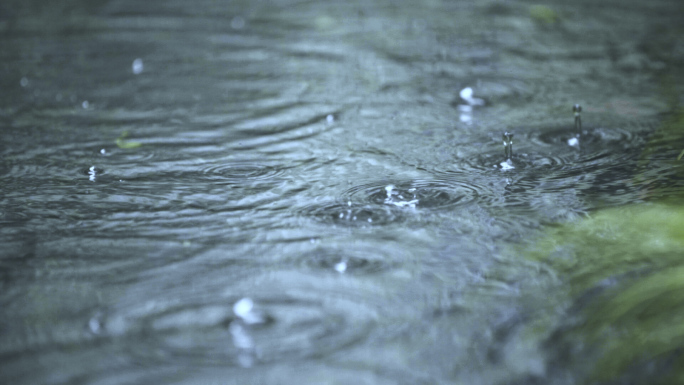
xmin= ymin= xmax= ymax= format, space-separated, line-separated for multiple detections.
xmin=527 ymin=204 xmax=684 ymax=383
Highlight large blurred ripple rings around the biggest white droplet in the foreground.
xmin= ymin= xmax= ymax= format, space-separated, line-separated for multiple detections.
xmin=101 ymin=272 xmax=392 ymax=366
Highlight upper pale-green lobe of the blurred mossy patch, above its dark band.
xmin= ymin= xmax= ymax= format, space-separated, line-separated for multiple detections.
xmin=530 ymin=205 xmax=684 ymax=293
